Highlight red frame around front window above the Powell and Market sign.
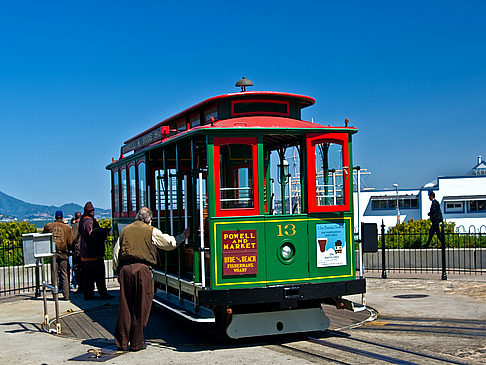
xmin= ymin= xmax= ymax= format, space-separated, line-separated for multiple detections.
xmin=213 ymin=137 xmax=259 ymax=217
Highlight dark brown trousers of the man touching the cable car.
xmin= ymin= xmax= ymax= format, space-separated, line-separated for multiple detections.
xmin=115 ymin=264 xmax=154 ymax=350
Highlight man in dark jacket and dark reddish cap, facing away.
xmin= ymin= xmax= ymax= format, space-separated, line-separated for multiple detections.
xmin=79 ymin=202 xmax=114 ymax=300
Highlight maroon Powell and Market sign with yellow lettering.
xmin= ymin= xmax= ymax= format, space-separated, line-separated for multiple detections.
xmin=222 ymin=229 xmax=258 ymax=276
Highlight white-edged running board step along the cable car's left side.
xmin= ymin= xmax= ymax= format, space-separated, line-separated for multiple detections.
xmin=153 ymin=290 xmax=215 ymax=323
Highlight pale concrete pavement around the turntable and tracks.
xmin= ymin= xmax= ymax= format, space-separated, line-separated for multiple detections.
xmin=0 ymin=272 xmax=486 ymax=365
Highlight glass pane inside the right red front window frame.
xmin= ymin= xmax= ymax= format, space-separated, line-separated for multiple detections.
xmin=315 ymin=143 xmax=344 ymax=206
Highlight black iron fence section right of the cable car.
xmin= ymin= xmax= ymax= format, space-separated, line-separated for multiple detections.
xmin=357 ymin=225 xmax=486 ymax=279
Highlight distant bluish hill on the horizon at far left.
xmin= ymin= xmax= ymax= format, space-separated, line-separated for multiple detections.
xmin=0 ymin=191 xmax=111 ymax=220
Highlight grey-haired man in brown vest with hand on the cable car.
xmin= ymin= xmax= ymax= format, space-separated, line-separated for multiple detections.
xmin=113 ymin=207 xmax=190 ymax=351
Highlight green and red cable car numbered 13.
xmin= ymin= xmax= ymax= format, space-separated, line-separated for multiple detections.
xmin=107 ymin=79 xmax=365 ymax=338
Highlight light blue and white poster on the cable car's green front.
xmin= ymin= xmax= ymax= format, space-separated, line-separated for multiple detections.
xmin=316 ymin=223 xmax=347 ymax=267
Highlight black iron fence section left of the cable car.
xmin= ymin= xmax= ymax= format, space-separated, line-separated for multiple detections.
xmin=0 ymin=237 xmax=115 ymax=296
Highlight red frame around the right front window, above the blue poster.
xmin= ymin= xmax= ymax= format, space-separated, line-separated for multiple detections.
xmin=306 ymin=133 xmax=351 ymax=213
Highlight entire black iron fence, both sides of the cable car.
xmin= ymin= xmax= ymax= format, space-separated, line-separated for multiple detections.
xmin=0 ymin=226 xmax=486 ymax=296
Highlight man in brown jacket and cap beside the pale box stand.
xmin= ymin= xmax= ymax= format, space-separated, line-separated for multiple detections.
xmin=42 ymin=210 xmax=73 ymax=300
